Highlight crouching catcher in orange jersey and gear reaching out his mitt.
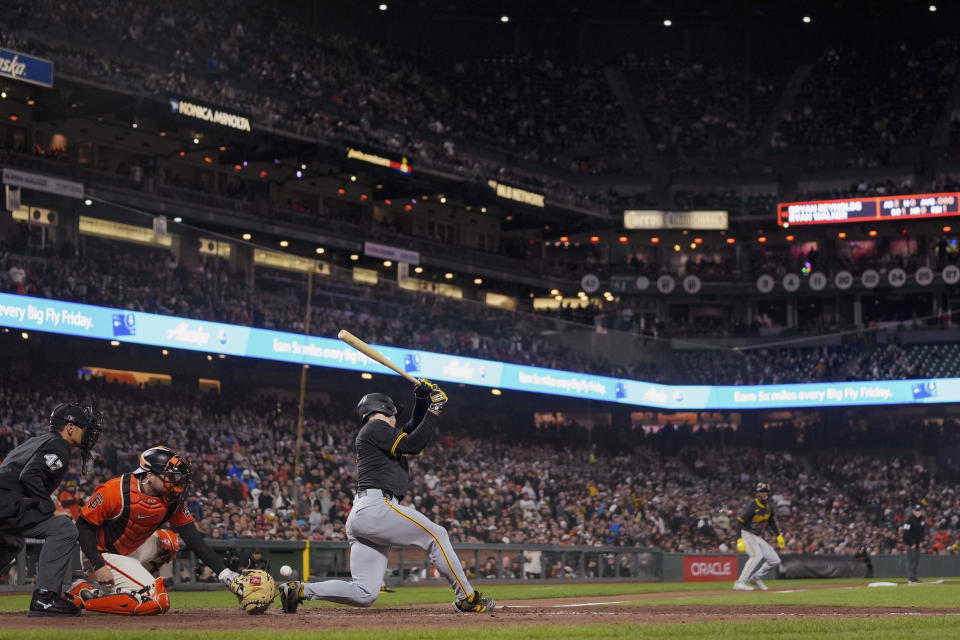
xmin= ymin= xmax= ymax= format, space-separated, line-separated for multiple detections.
xmin=68 ymin=446 xmax=275 ymax=616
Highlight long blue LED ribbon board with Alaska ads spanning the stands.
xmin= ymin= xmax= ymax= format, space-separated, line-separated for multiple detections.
xmin=0 ymin=293 xmax=960 ymax=410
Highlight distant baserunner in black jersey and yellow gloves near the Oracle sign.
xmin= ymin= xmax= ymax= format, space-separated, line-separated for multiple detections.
xmin=733 ymin=482 xmax=787 ymax=591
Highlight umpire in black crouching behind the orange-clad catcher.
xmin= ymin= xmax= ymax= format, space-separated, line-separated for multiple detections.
xmin=0 ymin=404 xmax=100 ymax=615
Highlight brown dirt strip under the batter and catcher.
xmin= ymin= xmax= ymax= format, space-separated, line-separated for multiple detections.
xmin=0 ymin=591 xmax=960 ymax=632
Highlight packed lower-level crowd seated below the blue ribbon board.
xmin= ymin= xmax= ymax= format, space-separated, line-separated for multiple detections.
xmin=0 ymin=372 xmax=960 ymax=584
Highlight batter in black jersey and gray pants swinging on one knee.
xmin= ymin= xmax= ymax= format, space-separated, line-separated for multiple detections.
xmin=280 ymin=378 xmax=496 ymax=613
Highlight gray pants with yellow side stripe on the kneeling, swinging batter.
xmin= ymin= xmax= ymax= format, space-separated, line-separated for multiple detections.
xmin=303 ymin=489 xmax=473 ymax=607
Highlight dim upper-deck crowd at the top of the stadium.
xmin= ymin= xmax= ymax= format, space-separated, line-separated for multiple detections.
xmin=0 ymin=0 xmax=957 ymax=209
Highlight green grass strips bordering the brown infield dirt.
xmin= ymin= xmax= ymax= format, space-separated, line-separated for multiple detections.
xmin=0 ymin=580 xmax=960 ymax=640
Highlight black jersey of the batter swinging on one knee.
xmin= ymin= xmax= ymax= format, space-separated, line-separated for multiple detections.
xmin=356 ymin=400 xmax=436 ymax=498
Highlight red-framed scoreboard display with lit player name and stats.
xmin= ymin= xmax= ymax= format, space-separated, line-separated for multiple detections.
xmin=777 ymin=193 xmax=960 ymax=226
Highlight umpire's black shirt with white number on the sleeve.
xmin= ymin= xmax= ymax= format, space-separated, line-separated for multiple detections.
xmin=0 ymin=433 xmax=72 ymax=511
